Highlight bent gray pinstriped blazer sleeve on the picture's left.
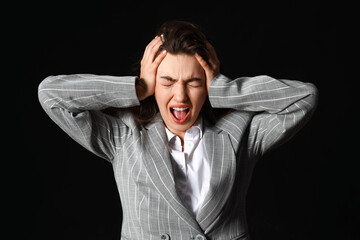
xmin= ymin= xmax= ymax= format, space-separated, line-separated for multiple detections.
xmin=38 ymin=74 xmax=140 ymax=161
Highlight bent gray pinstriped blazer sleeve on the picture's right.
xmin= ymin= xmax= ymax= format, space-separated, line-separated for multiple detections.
xmin=209 ymin=74 xmax=318 ymax=155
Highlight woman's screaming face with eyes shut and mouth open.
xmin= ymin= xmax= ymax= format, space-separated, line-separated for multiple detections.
xmin=155 ymin=53 xmax=207 ymax=136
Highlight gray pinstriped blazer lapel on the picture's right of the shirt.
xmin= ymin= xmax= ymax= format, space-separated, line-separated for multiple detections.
xmin=197 ymin=122 xmax=236 ymax=233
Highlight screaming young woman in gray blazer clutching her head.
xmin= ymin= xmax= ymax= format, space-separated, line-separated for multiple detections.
xmin=39 ymin=21 xmax=317 ymax=240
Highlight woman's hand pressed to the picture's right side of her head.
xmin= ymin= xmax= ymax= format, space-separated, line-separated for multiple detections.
xmin=195 ymin=42 xmax=220 ymax=93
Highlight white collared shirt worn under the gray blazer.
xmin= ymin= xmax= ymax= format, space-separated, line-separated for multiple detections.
xmin=165 ymin=118 xmax=211 ymax=216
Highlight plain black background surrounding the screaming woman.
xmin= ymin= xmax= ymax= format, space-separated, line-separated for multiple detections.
xmin=8 ymin=1 xmax=360 ymax=240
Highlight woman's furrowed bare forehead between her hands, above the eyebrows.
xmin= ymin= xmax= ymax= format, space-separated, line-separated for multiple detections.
xmin=157 ymin=53 xmax=204 ymax=79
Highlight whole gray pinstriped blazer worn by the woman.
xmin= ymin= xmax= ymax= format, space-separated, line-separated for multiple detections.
xmin=39 ymin=74 xmax=317 ymax=240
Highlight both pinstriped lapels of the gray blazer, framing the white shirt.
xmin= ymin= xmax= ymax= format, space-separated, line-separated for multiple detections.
xmin=142 ymin=113 xmax=236 ymax=232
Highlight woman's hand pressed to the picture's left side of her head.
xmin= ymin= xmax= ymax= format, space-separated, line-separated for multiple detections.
xmin=136 ymin=36 xmax=166 ymax=101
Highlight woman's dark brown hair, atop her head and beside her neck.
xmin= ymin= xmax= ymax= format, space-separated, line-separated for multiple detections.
xmin=107 ymin=21 xmax=228 ymax=124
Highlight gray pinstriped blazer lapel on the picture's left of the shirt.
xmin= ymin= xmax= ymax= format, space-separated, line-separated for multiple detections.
xmin=142 ymin=115 xmax=201 ymax=231
